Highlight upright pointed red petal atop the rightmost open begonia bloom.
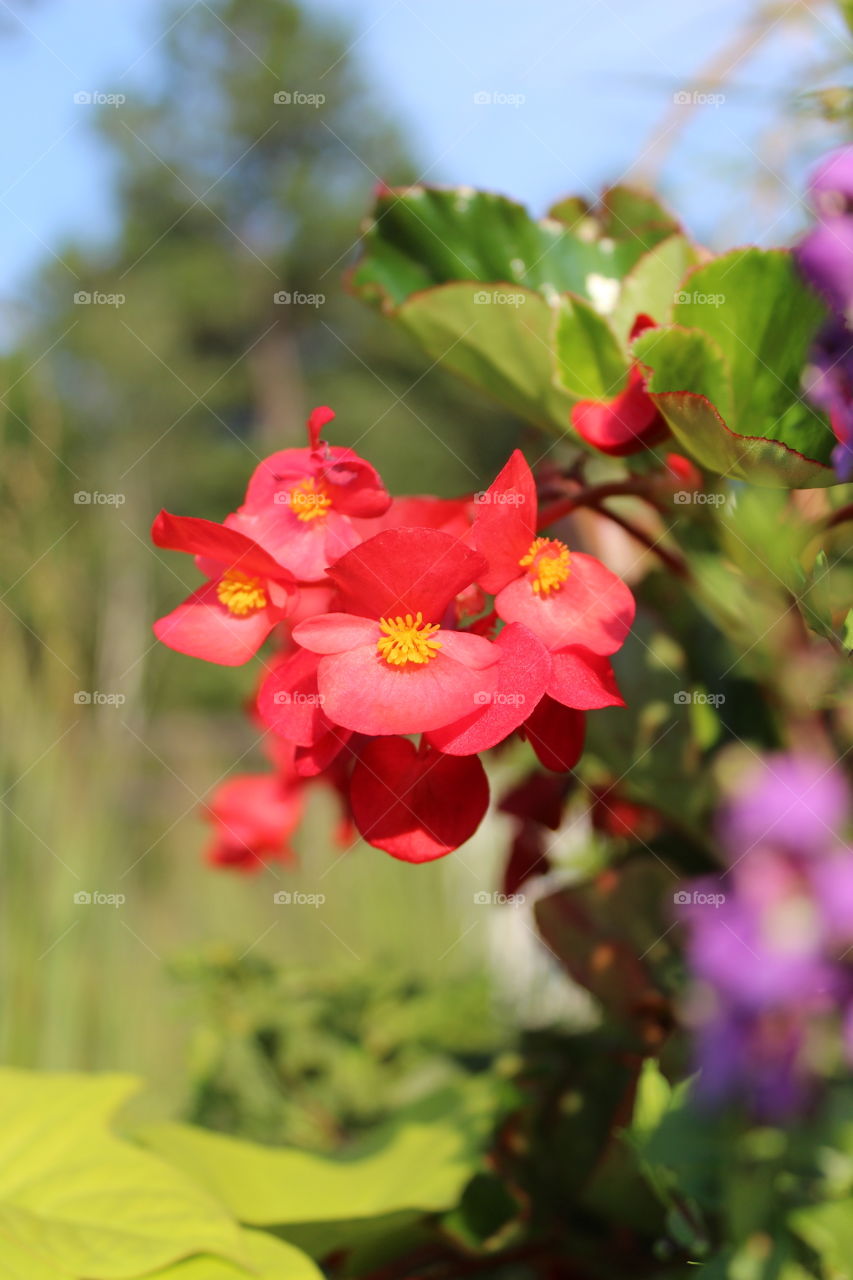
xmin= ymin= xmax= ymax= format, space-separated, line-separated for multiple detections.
xmin=471 ymin=449 xmax=537 ymax=593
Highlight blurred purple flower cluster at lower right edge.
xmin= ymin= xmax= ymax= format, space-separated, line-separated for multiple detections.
xmin=679 ymin=755 xmax=853 ymax=1117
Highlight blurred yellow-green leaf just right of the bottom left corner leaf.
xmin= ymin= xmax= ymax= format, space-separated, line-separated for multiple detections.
xmin=141 ymin=1100 xmax=481 ymax=1225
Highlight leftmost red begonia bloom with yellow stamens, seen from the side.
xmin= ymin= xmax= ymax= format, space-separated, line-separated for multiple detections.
xmin=151 ymin=511 xmax=296 ymax=667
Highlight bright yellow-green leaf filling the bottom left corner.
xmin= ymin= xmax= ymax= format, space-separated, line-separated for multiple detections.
xmin=0 ymin=1070 xmax=242 ymax=1280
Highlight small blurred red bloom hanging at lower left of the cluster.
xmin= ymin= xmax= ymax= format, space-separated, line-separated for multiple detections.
xmin=202 ymin=773 xmax=302 ymax=872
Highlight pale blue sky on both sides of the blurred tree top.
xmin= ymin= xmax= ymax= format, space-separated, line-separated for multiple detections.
xmin=0 ymin=0 xmax=839 ymax=300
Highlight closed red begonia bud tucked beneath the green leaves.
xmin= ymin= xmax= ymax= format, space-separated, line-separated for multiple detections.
xmin=571 ymin=315 xmax=670 ymax=458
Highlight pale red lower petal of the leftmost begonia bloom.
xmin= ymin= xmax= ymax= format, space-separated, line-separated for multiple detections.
xmin=154 ymin=582 xmax=274 ymax=667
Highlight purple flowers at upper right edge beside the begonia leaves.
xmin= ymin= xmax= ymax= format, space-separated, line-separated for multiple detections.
xmin=795 ymin=147 xmax=853 ymax=480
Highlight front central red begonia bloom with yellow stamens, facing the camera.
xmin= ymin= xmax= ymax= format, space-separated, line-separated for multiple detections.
xmin=293 ymin=529 xmax=500 ymax=735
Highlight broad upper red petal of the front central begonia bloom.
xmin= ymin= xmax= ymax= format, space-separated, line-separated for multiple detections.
xmin=329 ymin=529 xmax=485 ymax=622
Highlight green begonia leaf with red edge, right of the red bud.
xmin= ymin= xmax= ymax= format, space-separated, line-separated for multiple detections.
xmin=633 ymin=248 xmax=835 ymax=488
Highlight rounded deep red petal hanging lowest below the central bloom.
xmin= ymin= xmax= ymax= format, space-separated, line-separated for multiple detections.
xmin=350 ymin=737 xmax=489 ymax=863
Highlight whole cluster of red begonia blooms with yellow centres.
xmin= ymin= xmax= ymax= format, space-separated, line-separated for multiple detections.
xmin=152 ymin=408 xmax=634 ymax=869
